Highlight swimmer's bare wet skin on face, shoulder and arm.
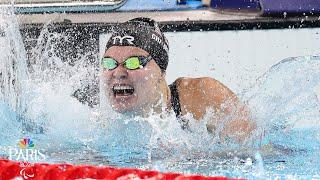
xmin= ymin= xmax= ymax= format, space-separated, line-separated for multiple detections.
xmin=102 ymin=46 xmax=255 ymax=141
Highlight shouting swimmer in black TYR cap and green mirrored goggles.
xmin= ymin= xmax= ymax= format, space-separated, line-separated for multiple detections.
xmin=101 ymin=18 xmax=255 ymax=140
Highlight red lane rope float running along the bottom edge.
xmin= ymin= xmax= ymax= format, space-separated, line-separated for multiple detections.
xmin=0 ymin=159 xmax=234 ymax=180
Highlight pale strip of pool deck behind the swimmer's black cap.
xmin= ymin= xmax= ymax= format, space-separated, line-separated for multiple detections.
xmin=19 ymin=10 xmax=263 ymax=24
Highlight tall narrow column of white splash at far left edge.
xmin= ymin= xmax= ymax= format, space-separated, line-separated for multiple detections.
xmin=0 ymin=8 xmax=28 ymax=115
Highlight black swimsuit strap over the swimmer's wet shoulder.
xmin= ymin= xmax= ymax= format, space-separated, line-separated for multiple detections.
xmin=169 ymin=81 xmax=189 ymax=130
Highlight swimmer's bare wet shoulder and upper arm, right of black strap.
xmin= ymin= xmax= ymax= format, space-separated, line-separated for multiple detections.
xmin=176 ymin=77 xmax=255 ymax=141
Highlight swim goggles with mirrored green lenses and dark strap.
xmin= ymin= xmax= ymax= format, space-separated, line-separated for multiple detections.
xmin=101 ymin=56 xmax=152 ymax=70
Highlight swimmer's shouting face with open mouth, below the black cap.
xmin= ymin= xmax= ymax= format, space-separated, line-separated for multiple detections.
xmin=102 ymin=46 xmax=164 ymax=113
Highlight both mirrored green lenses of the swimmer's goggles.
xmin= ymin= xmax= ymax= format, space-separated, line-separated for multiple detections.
xmin=101 ymin=57 xmax=142 ymax=70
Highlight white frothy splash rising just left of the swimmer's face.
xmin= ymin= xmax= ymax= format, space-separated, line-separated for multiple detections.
xmin=25 ymin=24 xmax=97 ymax=151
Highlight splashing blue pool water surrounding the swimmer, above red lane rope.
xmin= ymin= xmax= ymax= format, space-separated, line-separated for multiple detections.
xmin=0 ymin=7 xmax=320 ymax=179
